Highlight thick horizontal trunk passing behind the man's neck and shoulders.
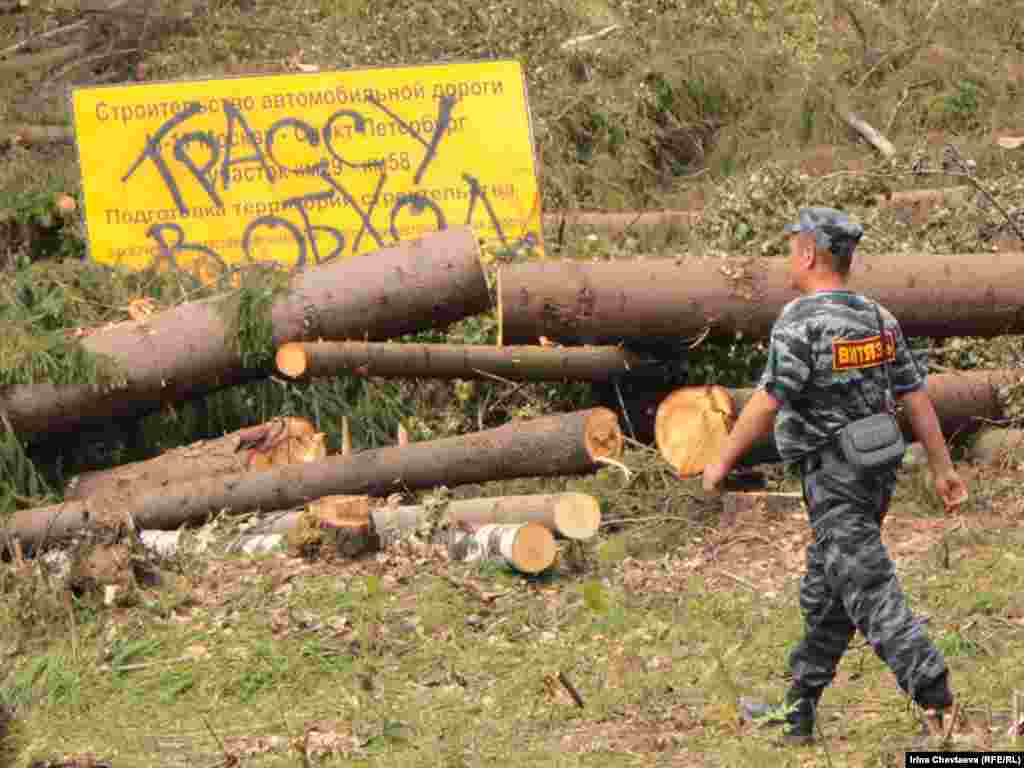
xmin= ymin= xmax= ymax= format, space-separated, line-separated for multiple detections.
xmin=498 ymin=253 xmax=1024 ymax=345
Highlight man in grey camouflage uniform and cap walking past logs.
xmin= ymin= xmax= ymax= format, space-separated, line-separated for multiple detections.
xmin=703 ymin=208 xmax=967 ymax=743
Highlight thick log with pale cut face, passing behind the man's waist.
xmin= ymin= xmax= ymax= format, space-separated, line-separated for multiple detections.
xmin=656 ymin=370 xmax=1024 ymax=474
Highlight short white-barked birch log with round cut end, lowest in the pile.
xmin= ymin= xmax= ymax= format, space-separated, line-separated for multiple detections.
xmin=449 ymin=522 xmax=558 ymax=573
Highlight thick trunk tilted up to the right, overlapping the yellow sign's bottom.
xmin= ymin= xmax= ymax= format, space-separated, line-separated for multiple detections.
xmin=0 ymin=227 xmax=490 ymax=442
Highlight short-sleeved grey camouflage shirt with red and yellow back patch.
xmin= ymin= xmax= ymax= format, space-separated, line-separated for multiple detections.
xmin=759 ymin=291 xmax=927 ymax=462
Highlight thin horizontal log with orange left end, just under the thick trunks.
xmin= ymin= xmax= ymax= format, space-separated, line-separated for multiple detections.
xmin=278 ymin=341 xmax=642 ymax=382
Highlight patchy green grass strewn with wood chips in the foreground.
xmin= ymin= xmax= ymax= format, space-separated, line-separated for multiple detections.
xmin=0 ymin=481 xmax=1024 ymax=766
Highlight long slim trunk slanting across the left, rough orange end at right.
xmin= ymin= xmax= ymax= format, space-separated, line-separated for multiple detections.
xmin=0 ymin=408 xmax=623 ymax=548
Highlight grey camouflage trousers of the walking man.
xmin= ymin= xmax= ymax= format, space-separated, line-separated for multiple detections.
xmin=790 ymin=449 xmax=946 ymax=706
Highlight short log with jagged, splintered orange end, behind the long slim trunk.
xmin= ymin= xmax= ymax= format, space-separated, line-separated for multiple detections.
xmin=65 ymin=417 xmax=327 ymax=501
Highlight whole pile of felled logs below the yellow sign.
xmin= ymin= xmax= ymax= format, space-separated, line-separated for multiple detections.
xmin=0 ymin=219 xmax=1024 ymax=572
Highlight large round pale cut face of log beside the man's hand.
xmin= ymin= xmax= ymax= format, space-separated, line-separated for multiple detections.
xmin=654 ymin=385 xmax=736 ymax=477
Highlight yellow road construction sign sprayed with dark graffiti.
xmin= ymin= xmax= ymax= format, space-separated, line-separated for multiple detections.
xmin=72 ymin=60 xmax=543 ymax=272
